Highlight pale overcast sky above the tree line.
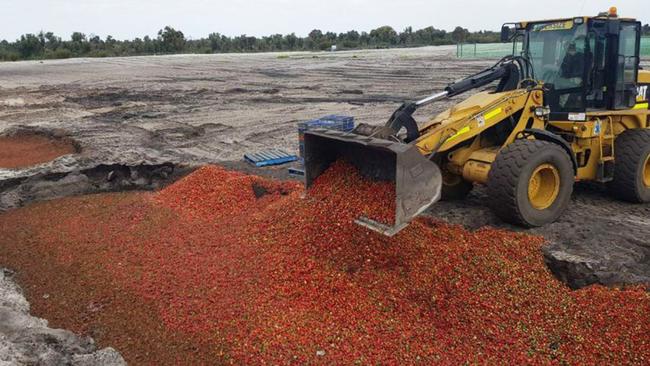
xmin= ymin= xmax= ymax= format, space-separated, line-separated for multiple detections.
xmin=0 ymin=0 xmax=650 ymax=40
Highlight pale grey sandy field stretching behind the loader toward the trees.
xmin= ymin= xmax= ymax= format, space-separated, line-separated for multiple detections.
xmin=0 ymin=48 xmax=466 ymax=162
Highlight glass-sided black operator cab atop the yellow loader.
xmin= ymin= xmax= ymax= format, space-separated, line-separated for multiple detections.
xmin=519 ymin=14 xmax=641 ymax=116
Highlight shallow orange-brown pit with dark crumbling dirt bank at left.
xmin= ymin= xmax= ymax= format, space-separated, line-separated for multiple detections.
xmin=0 ymin=126 xmax=191 ymax=212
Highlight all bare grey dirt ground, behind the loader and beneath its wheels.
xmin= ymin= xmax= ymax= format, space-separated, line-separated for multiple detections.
xmin=0 ymin=47 xmax=650 ymax=287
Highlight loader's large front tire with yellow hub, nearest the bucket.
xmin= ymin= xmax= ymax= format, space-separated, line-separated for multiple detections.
xmin=487 ymin=140 xmax=575 ymax=227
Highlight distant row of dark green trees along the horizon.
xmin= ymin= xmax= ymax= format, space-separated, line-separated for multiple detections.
xmin=0 ymin=24 xmax=650 ymax=61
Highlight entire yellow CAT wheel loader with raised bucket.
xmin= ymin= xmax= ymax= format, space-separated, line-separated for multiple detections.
xmin=304 ymin=8 xmax=650 ymax=235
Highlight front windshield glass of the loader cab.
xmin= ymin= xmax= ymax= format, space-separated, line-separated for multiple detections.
xmin=524 ymin=20 xmax=588 ymax=90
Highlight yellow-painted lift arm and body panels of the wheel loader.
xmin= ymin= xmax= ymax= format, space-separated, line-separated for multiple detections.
xmin=416 ymin=74 xmax=650 ymax=183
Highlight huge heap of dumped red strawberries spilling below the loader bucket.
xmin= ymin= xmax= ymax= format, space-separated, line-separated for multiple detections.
xmin=0 ymin=163 xmax=650 ymax=364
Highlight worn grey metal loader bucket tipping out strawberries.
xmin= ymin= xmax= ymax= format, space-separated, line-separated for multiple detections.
xmin=304 ymin=129 xmax=442 ymax=236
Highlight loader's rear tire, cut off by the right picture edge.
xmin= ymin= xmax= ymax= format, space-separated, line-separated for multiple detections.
xmin=609 ymin=129 xmax=650 ymax=203
